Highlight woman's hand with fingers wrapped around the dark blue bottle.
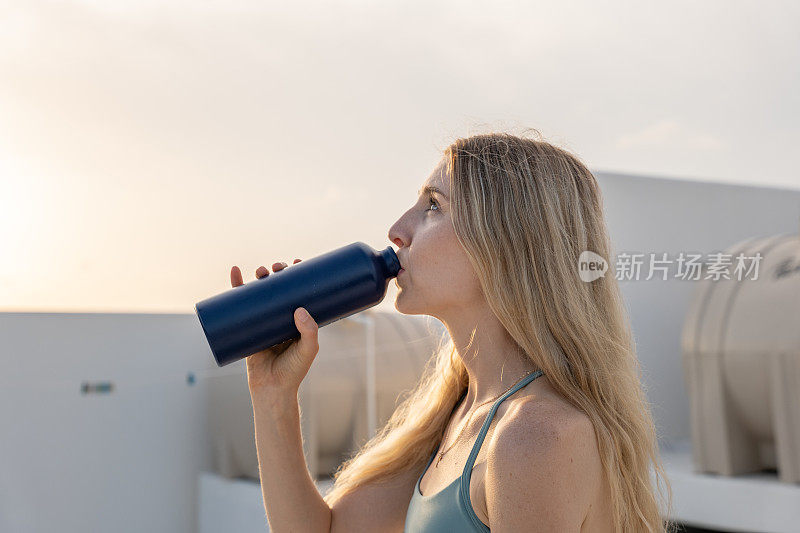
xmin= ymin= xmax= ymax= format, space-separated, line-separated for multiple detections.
xmin=231 ymin=259 xmax=319 ymax=397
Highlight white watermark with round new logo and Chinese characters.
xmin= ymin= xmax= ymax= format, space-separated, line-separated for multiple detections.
xmin=578 ymin=250 xmax=762 ymax=282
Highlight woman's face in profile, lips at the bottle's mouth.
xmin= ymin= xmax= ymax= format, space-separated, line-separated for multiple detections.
xmin=389 ymin=159 xmax=483 ymax=320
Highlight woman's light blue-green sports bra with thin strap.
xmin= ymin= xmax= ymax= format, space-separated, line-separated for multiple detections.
xmin=404 ymin=370 xmax=543 ymax=533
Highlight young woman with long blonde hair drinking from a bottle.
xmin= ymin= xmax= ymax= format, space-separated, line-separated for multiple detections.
xmin=231 ymin=130 xmax=674 ymax=533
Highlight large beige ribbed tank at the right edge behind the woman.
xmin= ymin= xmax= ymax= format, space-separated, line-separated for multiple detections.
xmin=682 ymin=234 xmax=800 ymax=483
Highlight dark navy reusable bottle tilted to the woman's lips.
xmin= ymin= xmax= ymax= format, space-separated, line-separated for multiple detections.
xmin=194 ymin=242 xmax=400 ymax=366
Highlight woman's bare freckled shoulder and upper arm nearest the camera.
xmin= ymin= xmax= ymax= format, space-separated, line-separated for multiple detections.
xmin=486 ymin=396 xmax=602 ymax=532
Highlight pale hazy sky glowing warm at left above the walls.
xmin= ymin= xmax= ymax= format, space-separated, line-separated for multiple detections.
xmin=0 ymin=0 xmax=800 ymax=313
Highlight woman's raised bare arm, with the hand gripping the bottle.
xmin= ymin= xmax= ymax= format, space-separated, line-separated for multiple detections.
xmin=238 ymin=259 xmax=422 ymax=533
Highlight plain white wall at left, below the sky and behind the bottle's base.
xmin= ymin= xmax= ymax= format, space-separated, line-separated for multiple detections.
xmin=0 ymin=313 xmax=219 ymax=533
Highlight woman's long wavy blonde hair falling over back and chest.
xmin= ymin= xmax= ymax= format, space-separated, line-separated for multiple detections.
xmin=325 ymin=130 xmax=675 ymax=532
